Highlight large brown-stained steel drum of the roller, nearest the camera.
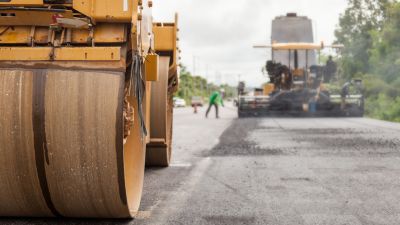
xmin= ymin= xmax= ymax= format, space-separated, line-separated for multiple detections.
xmin=0 ymin=69 xmax=145 ymax=218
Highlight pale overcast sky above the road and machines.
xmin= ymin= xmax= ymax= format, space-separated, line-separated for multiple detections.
xmin=153 ymin=0 xmax=347 ymax=86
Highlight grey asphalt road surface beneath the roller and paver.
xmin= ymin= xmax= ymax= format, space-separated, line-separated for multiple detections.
xmin=0 ymin=104 xmax=400 ymax=225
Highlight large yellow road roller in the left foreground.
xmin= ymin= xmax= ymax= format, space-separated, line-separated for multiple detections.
xmin=0 ymin=0 xmax=177 ymax=218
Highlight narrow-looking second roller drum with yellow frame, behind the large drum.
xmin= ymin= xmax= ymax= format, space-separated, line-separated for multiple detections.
xmin=146 ymin=14 xmax=179 ymax=167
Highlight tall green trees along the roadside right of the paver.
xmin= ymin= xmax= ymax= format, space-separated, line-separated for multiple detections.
xmin=335 ymin=0 xmax=400 ymax=122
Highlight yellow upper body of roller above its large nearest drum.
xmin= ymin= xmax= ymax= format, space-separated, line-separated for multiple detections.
xmin=0 ymin=0 xmax=153 ymax=60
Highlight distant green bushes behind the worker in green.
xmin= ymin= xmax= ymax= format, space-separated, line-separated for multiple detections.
xmin=175 ymin=65 xmax=236 ymax=103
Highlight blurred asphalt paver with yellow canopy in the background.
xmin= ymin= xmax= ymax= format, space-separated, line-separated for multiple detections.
xmin=238 ymin=13 xmax=364 ymax=117
